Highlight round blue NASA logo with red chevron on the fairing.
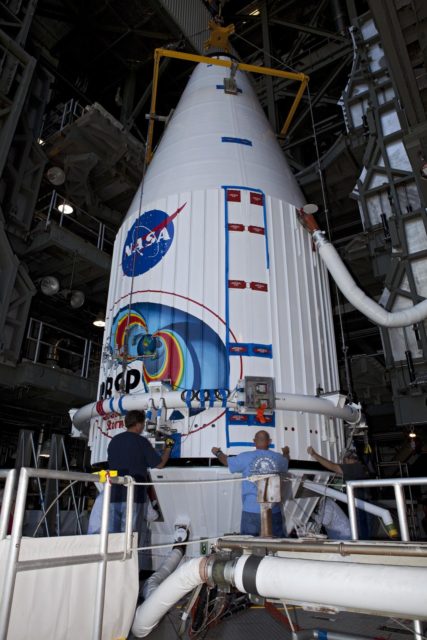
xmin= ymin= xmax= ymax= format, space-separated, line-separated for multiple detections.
xmin=122 ymin=203 xmax=187 ymax=277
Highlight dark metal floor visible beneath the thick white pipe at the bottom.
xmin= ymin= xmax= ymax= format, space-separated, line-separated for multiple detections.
xmin=128 ymin=607 xmax=414 ymax=640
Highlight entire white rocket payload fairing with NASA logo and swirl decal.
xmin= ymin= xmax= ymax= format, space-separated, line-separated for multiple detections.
xmin=83 ymin=55 xmax=342 ymax=462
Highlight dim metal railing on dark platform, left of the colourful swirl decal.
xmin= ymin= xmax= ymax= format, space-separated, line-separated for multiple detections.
xmin=24 ymin=318 xmax=100 ymax=379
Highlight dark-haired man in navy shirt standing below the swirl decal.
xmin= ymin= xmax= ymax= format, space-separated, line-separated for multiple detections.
xmin=108 ymin=411 xmax=172 ymax=556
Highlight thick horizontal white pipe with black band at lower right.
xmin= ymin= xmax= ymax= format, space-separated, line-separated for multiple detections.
xmin=233 ymin=555 xmax=427 ymax=618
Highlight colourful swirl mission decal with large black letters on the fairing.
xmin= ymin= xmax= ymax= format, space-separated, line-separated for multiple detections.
xmin=100 ymin=302 xmax=229 ymax=398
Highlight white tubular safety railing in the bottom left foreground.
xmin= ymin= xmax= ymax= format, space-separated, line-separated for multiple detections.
xmin=0 ymin=467 xmax=134 ymax=640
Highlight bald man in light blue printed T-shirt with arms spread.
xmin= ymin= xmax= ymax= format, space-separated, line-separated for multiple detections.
xmin=212 ymin=431 xmax=289 ymax=538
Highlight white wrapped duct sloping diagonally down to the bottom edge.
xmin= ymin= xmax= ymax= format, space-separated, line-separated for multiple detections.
xmin=132 ymin=557 xmax=206 ymax=638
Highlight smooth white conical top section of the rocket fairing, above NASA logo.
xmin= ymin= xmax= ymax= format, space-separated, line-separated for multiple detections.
xmin=127 ymin=61 xmax=304 ymax=213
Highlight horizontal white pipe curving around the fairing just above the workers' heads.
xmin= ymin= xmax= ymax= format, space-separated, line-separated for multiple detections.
xmin=72 ymin=391 xmax=361 ymax=430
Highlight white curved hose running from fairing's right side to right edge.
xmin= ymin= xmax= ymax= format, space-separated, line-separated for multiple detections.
xmin=313 ymin=231 xmax=427 ymax=329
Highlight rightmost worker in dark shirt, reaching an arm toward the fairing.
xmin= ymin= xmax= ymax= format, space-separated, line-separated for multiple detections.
xmin=307 ymin=447 xmax=371 ymax=540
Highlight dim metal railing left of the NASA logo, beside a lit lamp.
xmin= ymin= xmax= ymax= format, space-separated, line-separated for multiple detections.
xmin=37 ymin=190 xmax=115 ymax=254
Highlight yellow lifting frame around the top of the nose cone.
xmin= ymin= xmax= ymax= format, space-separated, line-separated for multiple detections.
xmin=145 ymin=49 xmax=309 ymax=165
